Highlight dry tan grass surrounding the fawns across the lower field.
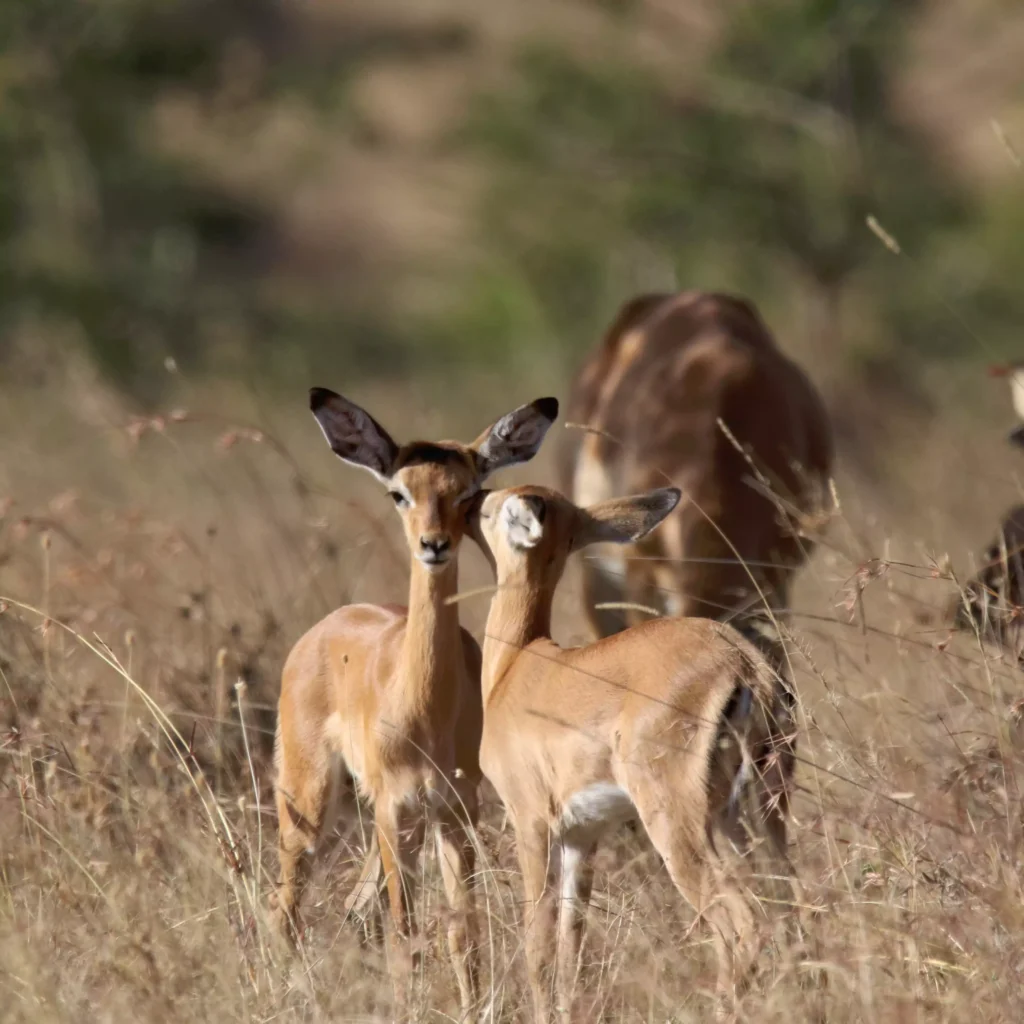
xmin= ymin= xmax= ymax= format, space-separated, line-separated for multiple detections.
xmin=0 ymin=370 xmax=1024 ymax=1024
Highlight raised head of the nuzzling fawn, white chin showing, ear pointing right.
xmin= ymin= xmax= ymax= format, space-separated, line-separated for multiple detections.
xmin=470 ymin=486 xmax=682 ymax=588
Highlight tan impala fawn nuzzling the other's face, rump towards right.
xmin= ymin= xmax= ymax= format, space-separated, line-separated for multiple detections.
xmin=470 ymin=486 xmax=792 ymax=1021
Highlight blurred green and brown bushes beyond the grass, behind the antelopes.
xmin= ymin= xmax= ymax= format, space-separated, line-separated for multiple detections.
xmin=0 ymin=0 xmax=1024 ymax=399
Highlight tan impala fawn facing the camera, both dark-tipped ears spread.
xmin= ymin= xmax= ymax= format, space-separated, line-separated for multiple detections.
xmin=275 ymin=388 xmax=558 ymax=1020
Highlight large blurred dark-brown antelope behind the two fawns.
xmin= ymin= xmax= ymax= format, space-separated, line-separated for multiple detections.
xmin=562 ymin=292 xmax=833 ymax=652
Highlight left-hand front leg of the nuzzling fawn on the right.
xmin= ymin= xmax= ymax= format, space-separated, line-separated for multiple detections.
xmin=515 ymin=821 xmax=556 ymax=1024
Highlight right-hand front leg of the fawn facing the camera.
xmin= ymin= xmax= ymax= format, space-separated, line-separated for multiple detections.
xmin=435 ymin=797 xmax=479 ymax=1024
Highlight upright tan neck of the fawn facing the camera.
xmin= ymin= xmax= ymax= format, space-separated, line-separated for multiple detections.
xmin=400 ymin=558 xmax=463 ymax=707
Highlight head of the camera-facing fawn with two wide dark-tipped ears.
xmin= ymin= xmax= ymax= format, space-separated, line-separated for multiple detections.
xmin=309 ymin=387 xmax=558 ymax=571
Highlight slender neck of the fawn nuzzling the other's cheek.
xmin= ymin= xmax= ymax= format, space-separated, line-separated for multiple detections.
xmin=481 ymin=572 xmax=554 ymax=705
